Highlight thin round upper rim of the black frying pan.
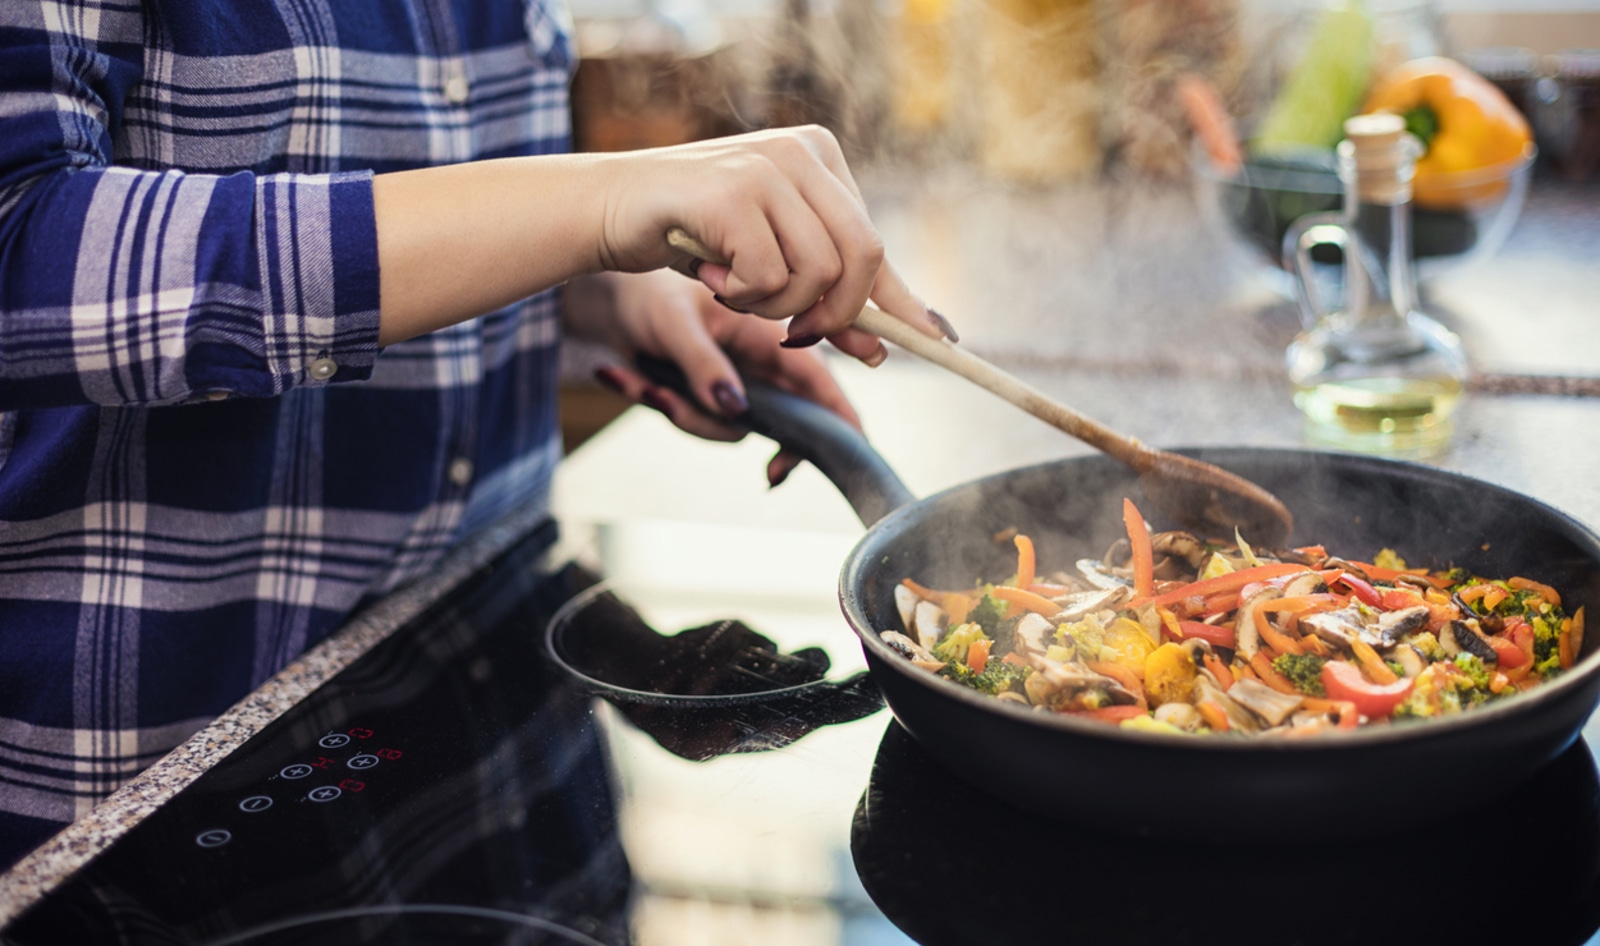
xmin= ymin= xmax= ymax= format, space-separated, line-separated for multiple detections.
xmin=838 ymin=445 xmax=1600 ymax=754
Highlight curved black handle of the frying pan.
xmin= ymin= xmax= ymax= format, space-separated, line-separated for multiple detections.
xmin=635 ymin=355 xmax=915 ymax=527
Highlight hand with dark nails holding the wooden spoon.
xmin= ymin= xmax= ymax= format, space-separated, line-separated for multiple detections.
xmin=588 ymin=126 xmax=944 ymax=363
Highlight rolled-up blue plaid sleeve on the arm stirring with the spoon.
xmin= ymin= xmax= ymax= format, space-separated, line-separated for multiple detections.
xmin=0 ymin=2 xmax=378 ymax=410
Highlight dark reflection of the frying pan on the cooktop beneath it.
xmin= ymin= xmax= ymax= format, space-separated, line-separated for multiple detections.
xmin=851 ymin=724 xmax=1600 ymax=946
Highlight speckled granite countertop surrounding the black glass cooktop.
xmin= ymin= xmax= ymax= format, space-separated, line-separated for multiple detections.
xmin=0 ymin=166 xmax=1600 ymax=925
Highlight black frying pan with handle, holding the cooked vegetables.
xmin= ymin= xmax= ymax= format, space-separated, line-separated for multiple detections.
xmin=720 ymin=374 xmax=1600 ymax=842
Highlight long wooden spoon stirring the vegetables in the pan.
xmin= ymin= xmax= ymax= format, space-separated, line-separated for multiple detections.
xmin=667 ymin=227 xmax=1294 ymax=547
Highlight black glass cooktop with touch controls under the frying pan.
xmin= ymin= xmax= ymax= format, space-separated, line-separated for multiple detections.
xmin=9 ymin=518 xmax=1600 ymax=946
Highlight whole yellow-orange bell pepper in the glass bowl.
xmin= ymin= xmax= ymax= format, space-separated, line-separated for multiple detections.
xmin=1362 ymin=56 xmax=1533 ymax=208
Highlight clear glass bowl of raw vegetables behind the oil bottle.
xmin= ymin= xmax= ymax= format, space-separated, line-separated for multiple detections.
xmin=1190 ymin=144 xmax=1536 ymax=296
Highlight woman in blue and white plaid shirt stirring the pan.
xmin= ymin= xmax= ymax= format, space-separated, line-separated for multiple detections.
xmin=0 ymin=0 xmax=936 ymax=866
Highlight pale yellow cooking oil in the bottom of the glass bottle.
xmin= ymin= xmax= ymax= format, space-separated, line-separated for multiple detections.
xmin=1294 ymin=376 xmax=1461 ymax=458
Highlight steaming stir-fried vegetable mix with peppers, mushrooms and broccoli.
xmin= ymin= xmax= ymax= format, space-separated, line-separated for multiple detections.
xmin=883 ymin=499 xmax=1584 ymax=736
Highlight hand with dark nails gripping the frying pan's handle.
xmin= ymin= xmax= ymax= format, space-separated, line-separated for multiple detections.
xmin=565 ymin=269 xmax=864 ymax=487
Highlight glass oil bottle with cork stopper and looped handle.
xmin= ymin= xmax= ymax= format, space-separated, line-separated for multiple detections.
xmin=1283 ymin=114 xmax=1467 ymax=459
